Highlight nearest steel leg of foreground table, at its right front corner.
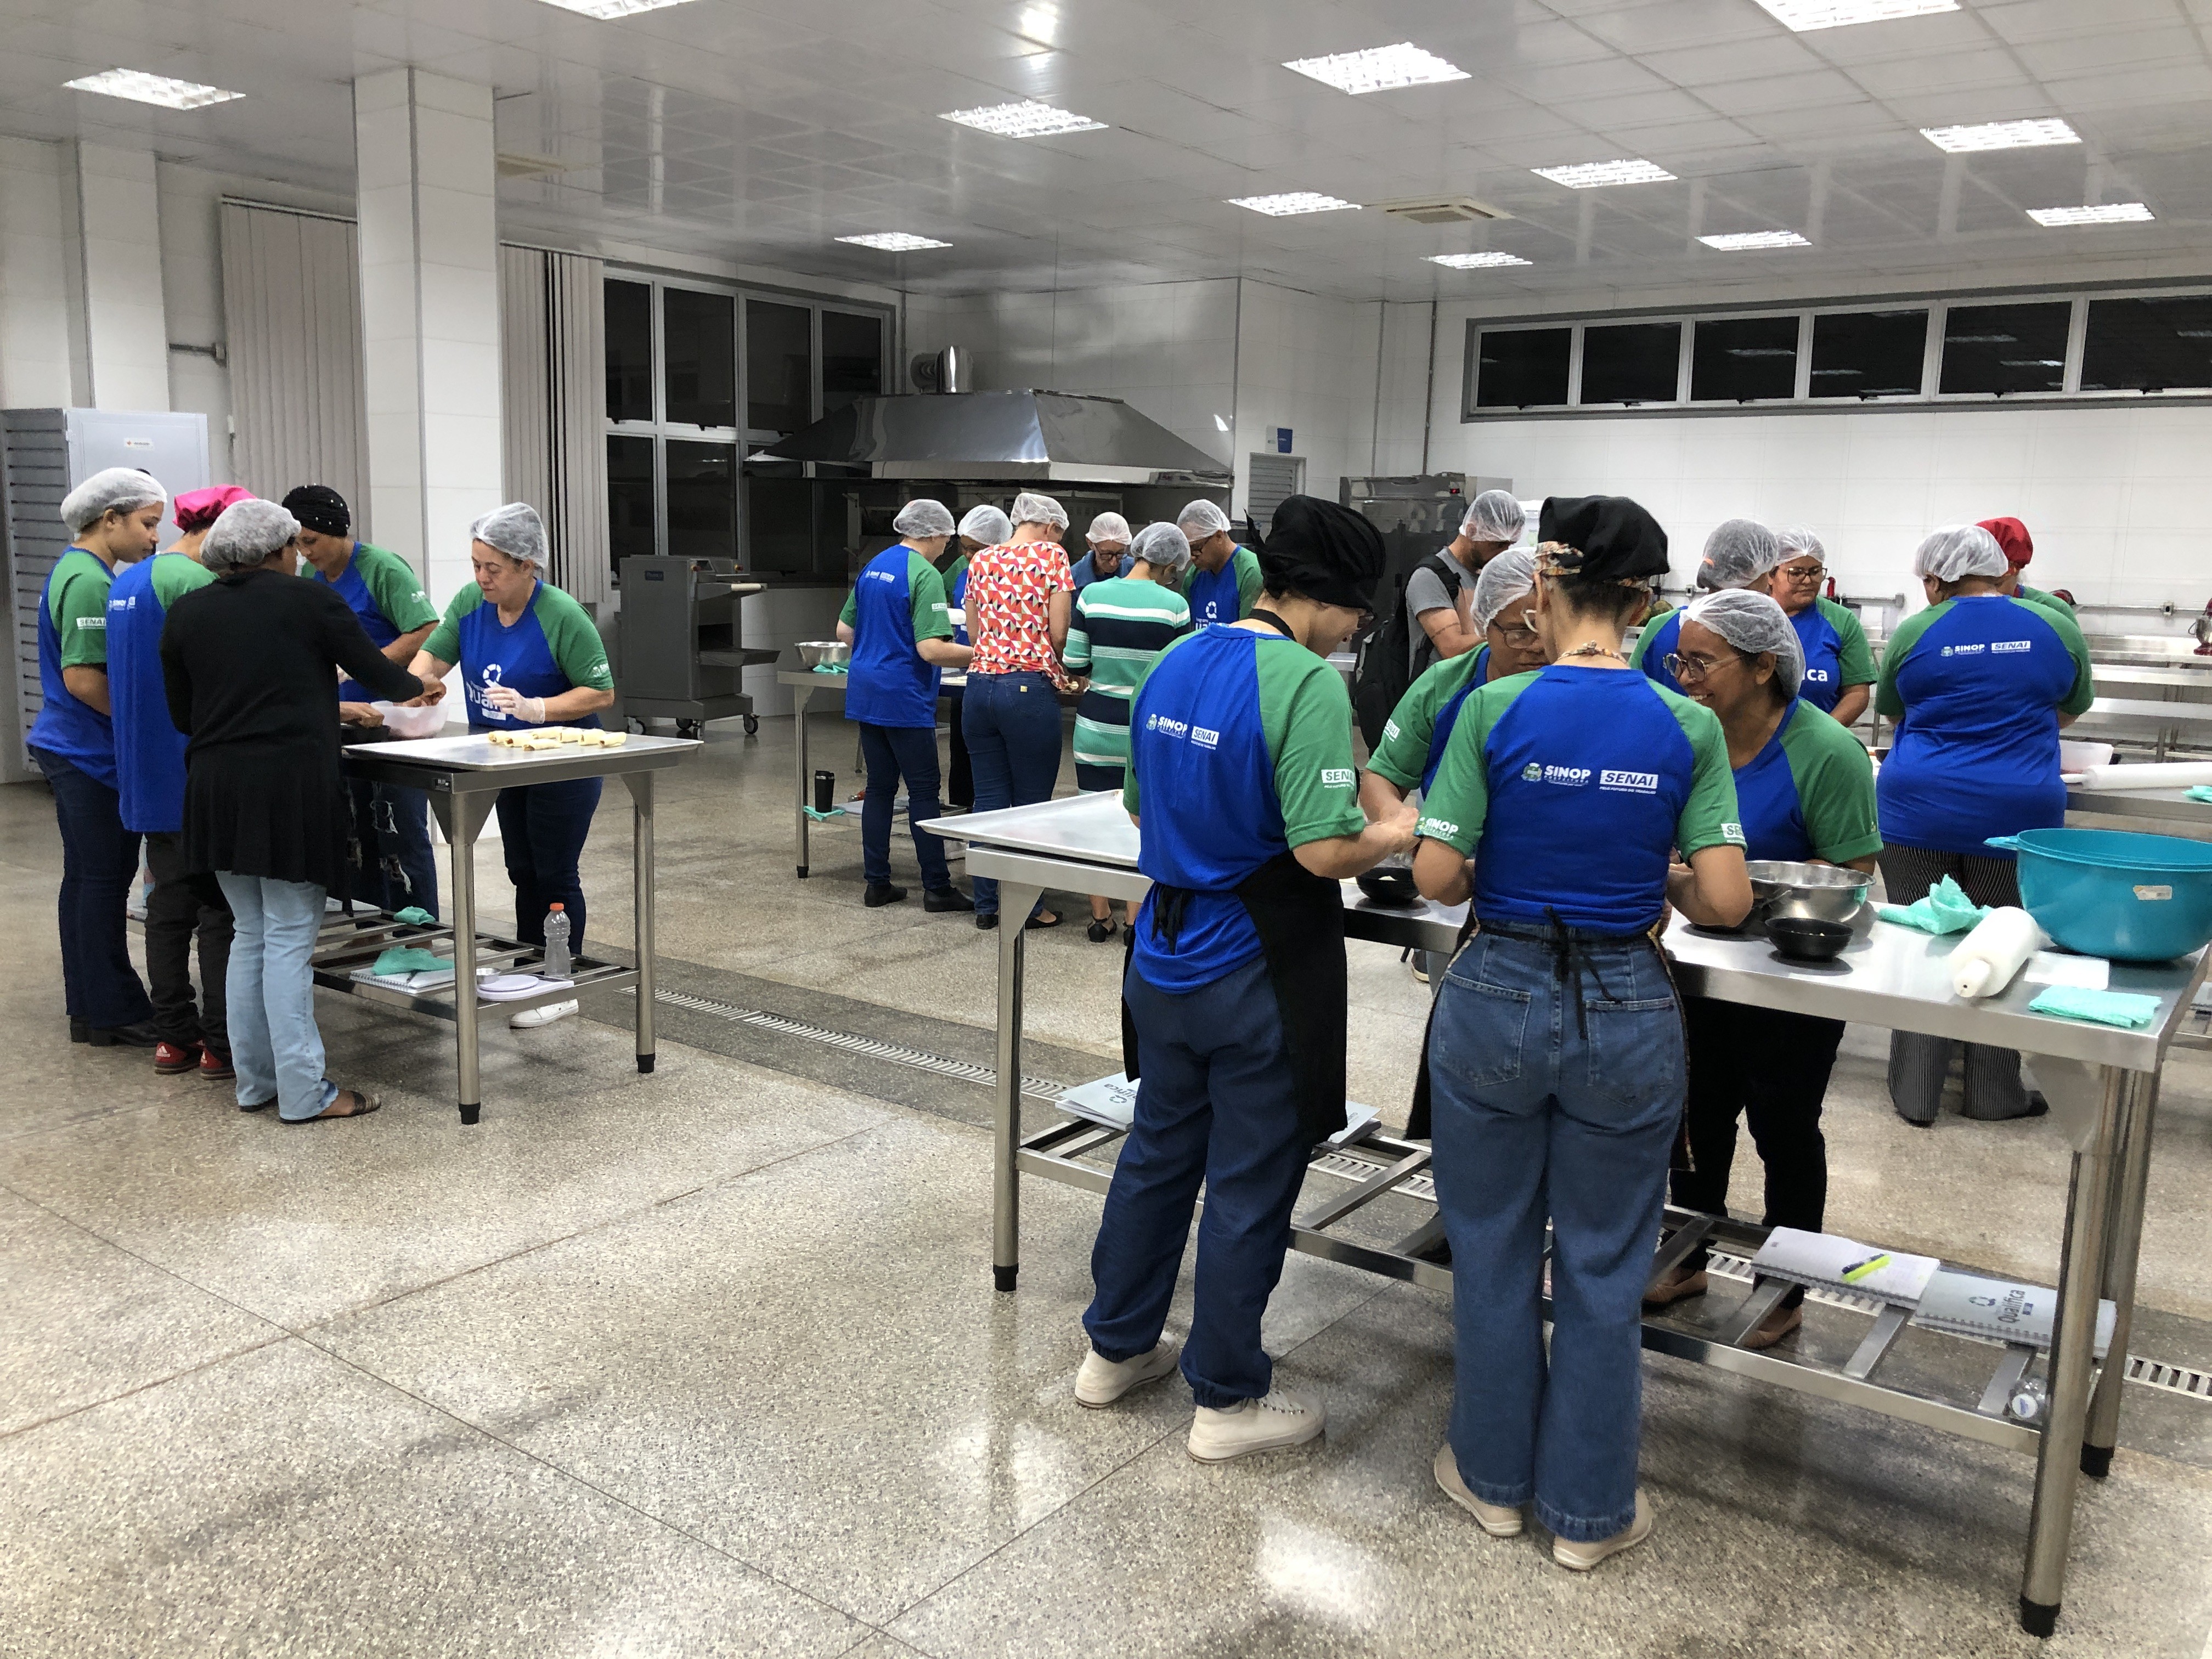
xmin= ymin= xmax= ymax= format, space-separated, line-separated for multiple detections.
xmin=2019 ymin=1066 xmax=2130 ymax=1637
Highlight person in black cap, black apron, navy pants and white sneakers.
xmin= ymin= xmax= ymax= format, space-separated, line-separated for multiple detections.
xmin=1075 ymin=495 xmax=1413 ymax=1462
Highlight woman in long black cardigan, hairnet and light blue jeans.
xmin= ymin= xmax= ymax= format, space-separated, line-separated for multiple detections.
xmin=161 ymin=500 xmax=444 ymax=1124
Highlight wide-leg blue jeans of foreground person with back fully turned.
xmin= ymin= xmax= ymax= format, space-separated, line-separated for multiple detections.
xmin=1429 ymin=934 xmax=1685 ymax=1542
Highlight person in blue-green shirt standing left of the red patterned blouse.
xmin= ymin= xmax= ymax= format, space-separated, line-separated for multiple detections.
xmin=836 ymin=500 xmax=975 ymax=911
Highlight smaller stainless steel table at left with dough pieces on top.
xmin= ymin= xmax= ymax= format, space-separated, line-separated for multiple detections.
xmin=314 ymin=735 xmax=699 ymax=1124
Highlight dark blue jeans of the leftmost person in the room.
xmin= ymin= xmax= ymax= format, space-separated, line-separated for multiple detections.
xmin=31 ymin=750 xmax=153 ymax=1031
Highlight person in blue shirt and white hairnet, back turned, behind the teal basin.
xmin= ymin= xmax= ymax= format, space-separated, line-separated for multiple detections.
xmin=1874 ymin=524 xmax=2097 ymax=1128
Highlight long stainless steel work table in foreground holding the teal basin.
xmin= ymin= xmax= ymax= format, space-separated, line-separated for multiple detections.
xmin=931 ymin=794 xmax=2205 ymax=1635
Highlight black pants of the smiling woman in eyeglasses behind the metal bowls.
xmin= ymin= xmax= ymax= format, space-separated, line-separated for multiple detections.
xmin=1674 ymin=997 xmax=1843 ymax=1301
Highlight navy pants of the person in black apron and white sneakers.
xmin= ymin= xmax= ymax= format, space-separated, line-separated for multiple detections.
xmin=1084 ymin=958 xmax=1312 ymax=1409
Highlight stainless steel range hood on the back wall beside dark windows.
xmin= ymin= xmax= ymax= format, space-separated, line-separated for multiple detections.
xmin=752 ymin=392 xmax=1232 ymax=489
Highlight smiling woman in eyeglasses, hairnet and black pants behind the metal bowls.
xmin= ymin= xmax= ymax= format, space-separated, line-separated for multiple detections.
xmin=1646 ymin=593 xmax=1882 ymax=1347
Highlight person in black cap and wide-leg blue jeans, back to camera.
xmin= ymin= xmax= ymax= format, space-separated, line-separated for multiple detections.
xmin=1413 ymin=495 xmax=1752 ymax=1571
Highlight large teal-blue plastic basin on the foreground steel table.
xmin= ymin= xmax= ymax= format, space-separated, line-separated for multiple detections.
xmin=1989 ymin=830 xmax=2212 ymax=962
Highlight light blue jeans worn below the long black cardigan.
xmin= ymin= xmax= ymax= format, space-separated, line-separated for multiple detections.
xmin=215 ymin=870 xmax=338 ymax=1124
